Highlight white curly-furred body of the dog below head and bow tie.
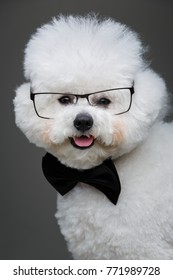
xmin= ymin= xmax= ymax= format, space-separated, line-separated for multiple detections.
xmin=56 ymin=123 xmax=173 ymax=259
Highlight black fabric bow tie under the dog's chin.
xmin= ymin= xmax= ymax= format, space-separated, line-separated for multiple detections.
xmin=42 ymin=153 xmax=121 ymax=204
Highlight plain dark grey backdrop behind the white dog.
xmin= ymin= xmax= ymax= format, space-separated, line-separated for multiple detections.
xmin=0 ymin=0 xmax=173 ymax=259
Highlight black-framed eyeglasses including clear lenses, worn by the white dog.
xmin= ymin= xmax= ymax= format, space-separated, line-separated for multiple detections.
xmin=30 ymin=86 xmax=135 ymax=119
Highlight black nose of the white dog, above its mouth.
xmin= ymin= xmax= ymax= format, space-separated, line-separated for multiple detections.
xmin=74 ymin=113 xmax=93 ymax=132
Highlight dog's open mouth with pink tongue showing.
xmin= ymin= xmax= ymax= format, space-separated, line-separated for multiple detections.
xmin=70 ymin=135 xmax=95 ymax=149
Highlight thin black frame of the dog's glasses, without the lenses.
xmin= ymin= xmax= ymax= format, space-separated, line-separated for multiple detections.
xmin=30 ymin=84 xmax=135 ymax=120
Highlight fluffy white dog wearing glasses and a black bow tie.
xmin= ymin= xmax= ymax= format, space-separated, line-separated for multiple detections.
xmin=14 ymin=15 xmax=173 ymax=259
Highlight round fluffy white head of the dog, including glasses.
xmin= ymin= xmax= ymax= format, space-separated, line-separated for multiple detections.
xmin=14 ymin=16 xmax=166 ymax=169
